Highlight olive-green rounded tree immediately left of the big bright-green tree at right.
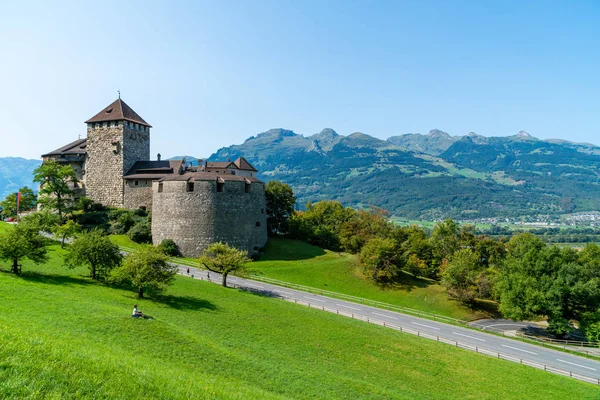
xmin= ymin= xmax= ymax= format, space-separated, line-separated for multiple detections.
xmin=442 ymin=249 xmax=478 ymax=305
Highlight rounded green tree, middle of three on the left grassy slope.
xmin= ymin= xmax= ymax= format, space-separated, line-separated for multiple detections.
xmin=65 ymin=230 xmax=122 ymax=279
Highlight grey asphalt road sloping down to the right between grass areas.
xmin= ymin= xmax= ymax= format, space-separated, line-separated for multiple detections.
xmin=179 ymin=265 xmax=600 ymax=379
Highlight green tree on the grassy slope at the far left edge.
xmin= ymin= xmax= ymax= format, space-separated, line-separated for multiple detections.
xmin=0 ymin=225 xmax=48 ymax=274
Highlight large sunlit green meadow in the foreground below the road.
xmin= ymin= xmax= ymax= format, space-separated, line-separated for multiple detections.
xmin=0 ymin=246 xmax=600 ymax=400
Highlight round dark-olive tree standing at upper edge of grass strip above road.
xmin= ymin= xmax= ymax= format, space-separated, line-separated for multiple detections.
xmin=360 ymin=238 xmax=401 ymax=283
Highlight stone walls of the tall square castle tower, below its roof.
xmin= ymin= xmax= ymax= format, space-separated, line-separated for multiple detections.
xmin=85 ymin=121 xmax=150 ymax=207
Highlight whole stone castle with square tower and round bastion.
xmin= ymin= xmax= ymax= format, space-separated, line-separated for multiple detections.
xmin=42 ymin=97 xmax=267 ymax=257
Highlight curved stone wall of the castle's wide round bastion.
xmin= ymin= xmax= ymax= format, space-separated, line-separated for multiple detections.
xmin=152 ymin=180 xmax=267 ymax=257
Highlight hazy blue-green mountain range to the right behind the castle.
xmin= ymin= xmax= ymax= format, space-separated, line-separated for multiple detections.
xmin=209 ymin=129 xmax=600 ymax=219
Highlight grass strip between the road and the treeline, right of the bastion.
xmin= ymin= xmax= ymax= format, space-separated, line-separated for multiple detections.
xmin=252 ymin=238 xmax=495 ymax=320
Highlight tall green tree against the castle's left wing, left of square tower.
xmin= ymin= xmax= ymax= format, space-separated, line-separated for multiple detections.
xmin=33 ymin=160 xmax=77 ymax=219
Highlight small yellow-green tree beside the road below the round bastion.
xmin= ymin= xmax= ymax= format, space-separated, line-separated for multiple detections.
xmin=199 ymin=242 xmax=250 ymax=287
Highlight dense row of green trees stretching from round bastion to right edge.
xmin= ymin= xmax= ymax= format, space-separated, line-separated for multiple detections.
xmin=267 ymin=183 xmax=600 ymax=341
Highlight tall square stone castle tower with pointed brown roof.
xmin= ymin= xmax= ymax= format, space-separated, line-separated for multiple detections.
xmin=85 ymin=98 xmax=151 ymax=207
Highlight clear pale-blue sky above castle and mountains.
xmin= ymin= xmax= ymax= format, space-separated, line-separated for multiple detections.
xmin=0 ymin=0 xmax=600 ymax=158
